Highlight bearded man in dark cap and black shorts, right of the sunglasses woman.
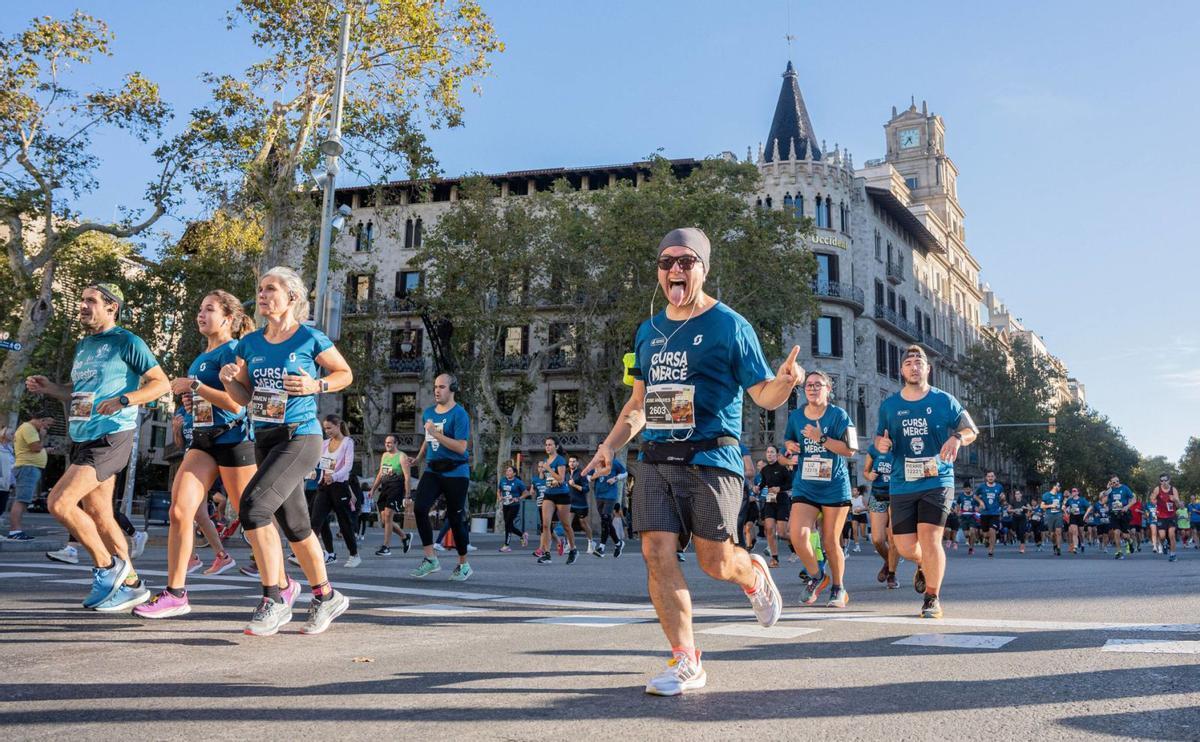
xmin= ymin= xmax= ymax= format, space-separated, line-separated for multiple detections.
xmin=875 ymin=346 xmax=978 ymax=618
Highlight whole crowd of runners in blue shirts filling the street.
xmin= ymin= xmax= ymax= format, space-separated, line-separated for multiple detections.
xmin=0 ymin=228 xmax=1200 ymax=695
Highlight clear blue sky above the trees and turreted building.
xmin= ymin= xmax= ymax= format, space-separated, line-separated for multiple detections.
xmin=32 ymin=0 xmax=1200 ymax=459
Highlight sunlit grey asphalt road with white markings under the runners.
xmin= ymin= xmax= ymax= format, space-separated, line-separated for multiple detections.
xmin=0 ymin=528 xmax=1200 ymax=741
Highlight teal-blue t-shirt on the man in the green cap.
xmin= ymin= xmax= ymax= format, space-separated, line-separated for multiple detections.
xmin=68 ymin=328 xmax=158 ymax=443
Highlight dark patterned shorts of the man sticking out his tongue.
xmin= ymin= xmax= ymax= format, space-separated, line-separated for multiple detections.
xmin=632 ymin=461 xmax=743 ymax=546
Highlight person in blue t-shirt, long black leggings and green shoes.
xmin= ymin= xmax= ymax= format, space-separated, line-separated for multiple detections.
xmin=408 ymin=373 xmax=474 ymax=582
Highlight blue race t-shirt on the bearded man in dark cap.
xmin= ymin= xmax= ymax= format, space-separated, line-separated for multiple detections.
xmin=875 ymin=387 xmax=967 ymax=495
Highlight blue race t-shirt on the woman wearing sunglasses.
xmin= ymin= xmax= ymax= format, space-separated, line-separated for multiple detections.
xmin=784 ymin=405 xmax=858 ymax=505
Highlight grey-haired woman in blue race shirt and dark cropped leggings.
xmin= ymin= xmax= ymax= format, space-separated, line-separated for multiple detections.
xmin=221 ymin=267 xmax=354 ymax=636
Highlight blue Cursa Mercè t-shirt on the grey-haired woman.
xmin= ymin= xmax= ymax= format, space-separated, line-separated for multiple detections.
xmin=234 ymin=324 xmax=334 ymax=436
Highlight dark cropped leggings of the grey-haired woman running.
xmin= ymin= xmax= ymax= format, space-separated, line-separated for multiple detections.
xmin=239 ymin=433 xmax=322 ymax=544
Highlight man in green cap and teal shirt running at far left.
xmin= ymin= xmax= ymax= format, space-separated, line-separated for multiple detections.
xmin=25 ymin=283 xmax=170 ymax=612
